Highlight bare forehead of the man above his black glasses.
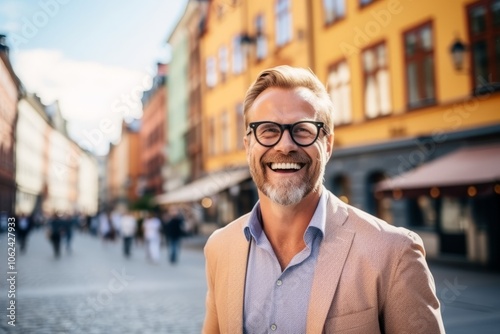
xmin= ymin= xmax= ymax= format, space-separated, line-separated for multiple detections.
xmin=248 ymin=87 xmax=317 ymax=122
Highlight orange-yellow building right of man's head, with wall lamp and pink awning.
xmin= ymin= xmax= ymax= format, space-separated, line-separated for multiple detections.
xmin=313 ymin=0 xmax=500 ymax=266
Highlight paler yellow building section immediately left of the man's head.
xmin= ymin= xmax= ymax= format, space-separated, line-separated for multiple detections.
xmin=194 ymin=0 xmax=313 ymax=223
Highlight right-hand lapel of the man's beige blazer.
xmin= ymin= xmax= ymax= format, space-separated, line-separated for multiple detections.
xmin=307 ymin=189 xmax=355 ymax=333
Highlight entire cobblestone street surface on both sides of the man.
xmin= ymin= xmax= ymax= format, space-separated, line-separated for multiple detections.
xmin=0 ymin=231 xmax=500 ymax=334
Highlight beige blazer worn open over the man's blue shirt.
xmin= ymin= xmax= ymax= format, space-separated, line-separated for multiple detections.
xmin=203 ymin=189 xmax=444 ymax=334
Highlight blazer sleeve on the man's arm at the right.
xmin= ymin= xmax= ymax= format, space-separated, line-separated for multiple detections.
xmin=381 ymin=232 xmax=445 ymax=334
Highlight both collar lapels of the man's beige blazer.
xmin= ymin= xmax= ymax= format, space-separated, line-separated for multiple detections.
xmin=226 ymin=189 xmax=355 ymax=333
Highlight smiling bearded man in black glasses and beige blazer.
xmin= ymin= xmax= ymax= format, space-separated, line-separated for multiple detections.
xmin=203 ymin=66 xmax=444 ymax=334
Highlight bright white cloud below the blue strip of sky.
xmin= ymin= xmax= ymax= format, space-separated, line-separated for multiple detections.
xmin=14 ymin=49 xmax=154 ymax=153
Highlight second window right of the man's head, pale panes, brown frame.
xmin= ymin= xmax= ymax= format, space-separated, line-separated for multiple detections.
xmin=362 ymin=44 xmax=391 ymax=118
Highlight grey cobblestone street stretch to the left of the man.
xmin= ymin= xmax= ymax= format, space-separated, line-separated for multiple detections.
xmin=0 ymin=231 xmax=206 ymax=334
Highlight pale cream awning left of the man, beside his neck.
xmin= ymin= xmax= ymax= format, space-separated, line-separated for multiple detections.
xmin=155 ymin=167 xmax=250 ymax=205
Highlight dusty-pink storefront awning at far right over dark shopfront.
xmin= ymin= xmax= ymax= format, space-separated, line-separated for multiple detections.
xmin=375 ymin=144 xmax=500 ymax=198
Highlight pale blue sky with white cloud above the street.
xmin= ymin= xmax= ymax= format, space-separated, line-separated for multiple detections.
xmin=0 ymin=0 xmax=187 ymax=155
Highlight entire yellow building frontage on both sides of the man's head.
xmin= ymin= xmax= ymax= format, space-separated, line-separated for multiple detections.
xmin=165 ymin=0 xmax=500 ymax=266
